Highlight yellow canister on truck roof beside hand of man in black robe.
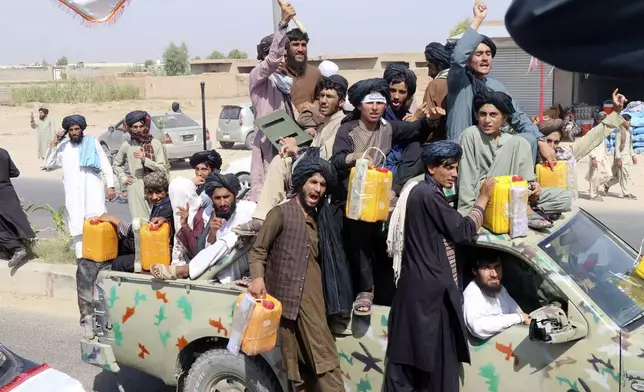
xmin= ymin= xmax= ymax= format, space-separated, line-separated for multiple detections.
xmin=483 ymin=176 xmax=528 ymax=234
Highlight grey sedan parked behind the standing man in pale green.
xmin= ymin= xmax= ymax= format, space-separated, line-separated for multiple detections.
xmin=98 ymin=113 xmax=212 ymax=160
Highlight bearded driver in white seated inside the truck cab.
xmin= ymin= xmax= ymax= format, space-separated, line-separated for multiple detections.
xmin=463 ymin=251 xmax=530 ymax=339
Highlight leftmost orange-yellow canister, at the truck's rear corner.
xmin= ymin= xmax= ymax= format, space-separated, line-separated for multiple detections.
xmin=83 ymin=218 xmax=119 ymax=263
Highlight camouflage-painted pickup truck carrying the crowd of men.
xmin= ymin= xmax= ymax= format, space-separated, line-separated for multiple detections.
xmin=81 ymin=210 xmax=644 ymax=392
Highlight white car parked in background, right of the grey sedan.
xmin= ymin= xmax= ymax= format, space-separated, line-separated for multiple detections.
xmin=216 ymin=102 xmax=255 ymax=150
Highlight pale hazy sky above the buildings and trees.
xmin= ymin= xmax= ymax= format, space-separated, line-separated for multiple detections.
xmin=0 ymin=0 xmax=510 ymax=65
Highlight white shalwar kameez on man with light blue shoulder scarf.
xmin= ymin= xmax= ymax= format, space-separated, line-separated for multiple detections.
xmin=45 ymin=140 xmax=114 ymax=258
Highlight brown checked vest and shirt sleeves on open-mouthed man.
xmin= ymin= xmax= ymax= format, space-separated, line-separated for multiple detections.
xmin=249 ymin=199 xmax=319 ymax=320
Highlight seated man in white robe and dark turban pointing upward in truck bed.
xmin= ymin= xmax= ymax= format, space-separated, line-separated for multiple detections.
xmin=150 ymin=173 xmax=256 ymax=283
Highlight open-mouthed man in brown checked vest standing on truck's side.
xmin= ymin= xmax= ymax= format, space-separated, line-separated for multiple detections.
xmin=250 ymin=157 xmax=344 ymax=392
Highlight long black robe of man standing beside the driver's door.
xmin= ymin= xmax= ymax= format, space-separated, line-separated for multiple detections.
xmin=387 ymin=174 xmax=477 ymax=376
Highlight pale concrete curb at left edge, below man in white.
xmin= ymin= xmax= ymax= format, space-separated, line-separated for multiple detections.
xmin=0 ymin=260 xmax=77 ymax=301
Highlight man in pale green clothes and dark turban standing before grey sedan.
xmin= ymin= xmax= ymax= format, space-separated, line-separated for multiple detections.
xmin=114 ymin=110 xmax=170 ymax=219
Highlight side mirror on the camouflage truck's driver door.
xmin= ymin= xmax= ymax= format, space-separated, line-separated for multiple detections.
xmin=528 ymin=305 xmax=588 ymax=344
